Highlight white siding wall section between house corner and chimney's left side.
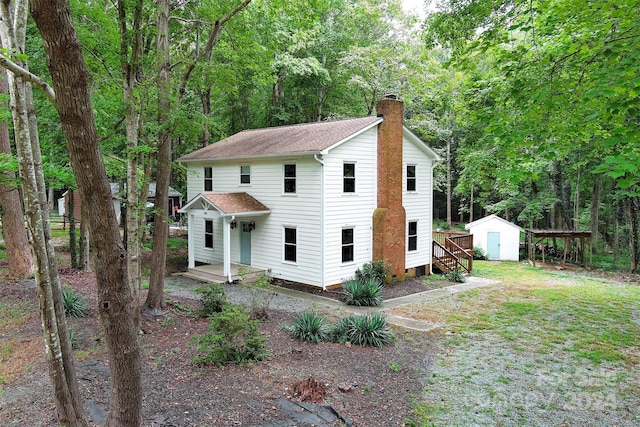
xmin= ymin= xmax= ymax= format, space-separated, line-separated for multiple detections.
xmin=324 ymin=127 xmax=378 ymax=286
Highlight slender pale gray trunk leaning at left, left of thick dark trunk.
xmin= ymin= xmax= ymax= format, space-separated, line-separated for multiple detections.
xmin=0 ymin=0 xmax=88 ymax=426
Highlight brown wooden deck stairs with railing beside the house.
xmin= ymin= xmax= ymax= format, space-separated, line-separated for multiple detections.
xmin=432 ymin=232 xmax=473 ymax=274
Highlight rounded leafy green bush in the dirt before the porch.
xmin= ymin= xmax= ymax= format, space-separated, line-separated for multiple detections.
xmin=194 ymin=304 xmax=267 ymax=366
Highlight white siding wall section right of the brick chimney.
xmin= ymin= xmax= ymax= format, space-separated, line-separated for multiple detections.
xmin=402 ymin=138 xmax=433 ymax=268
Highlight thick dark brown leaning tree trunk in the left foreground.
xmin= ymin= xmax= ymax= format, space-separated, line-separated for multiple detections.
xmin=30 ymin=0 xmax=142 ymax=427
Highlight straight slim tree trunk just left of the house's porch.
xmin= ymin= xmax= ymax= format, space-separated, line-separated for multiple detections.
xmin=145 ymin=0 xmax=171 ymax=311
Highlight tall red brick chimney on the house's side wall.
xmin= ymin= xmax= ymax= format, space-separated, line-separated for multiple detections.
xmin=373 ymin=99 xmax=406 ymax=280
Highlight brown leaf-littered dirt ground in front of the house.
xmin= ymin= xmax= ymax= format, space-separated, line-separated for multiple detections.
xmin=0 ymin=242 xmax=435 ymax=427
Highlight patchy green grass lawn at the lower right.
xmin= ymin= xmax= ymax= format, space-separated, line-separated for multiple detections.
xmin=394 ymin=261 xmax=640 ymax=426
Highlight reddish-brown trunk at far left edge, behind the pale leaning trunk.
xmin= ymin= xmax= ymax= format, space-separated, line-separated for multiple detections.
xmin=0 ymin=61 xmax=33 ymax=279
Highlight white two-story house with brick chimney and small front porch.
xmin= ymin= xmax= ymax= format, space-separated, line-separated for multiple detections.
xmin=178 ymin=99 xmax=439 ymax=289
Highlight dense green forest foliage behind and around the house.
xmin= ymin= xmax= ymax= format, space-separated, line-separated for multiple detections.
xmin=2 ymin=0 xmax=640 ymax=269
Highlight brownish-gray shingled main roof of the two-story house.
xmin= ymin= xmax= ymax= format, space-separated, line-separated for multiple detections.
xmin=178 ymin=116 xmax=382 ymax=162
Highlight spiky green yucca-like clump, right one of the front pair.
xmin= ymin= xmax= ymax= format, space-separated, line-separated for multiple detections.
xmin=332 ymin=312 xmax=394 ymax=347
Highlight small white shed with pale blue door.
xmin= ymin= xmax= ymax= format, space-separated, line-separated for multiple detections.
xmin=464 ymin=215 xmax=524 ymax=261
